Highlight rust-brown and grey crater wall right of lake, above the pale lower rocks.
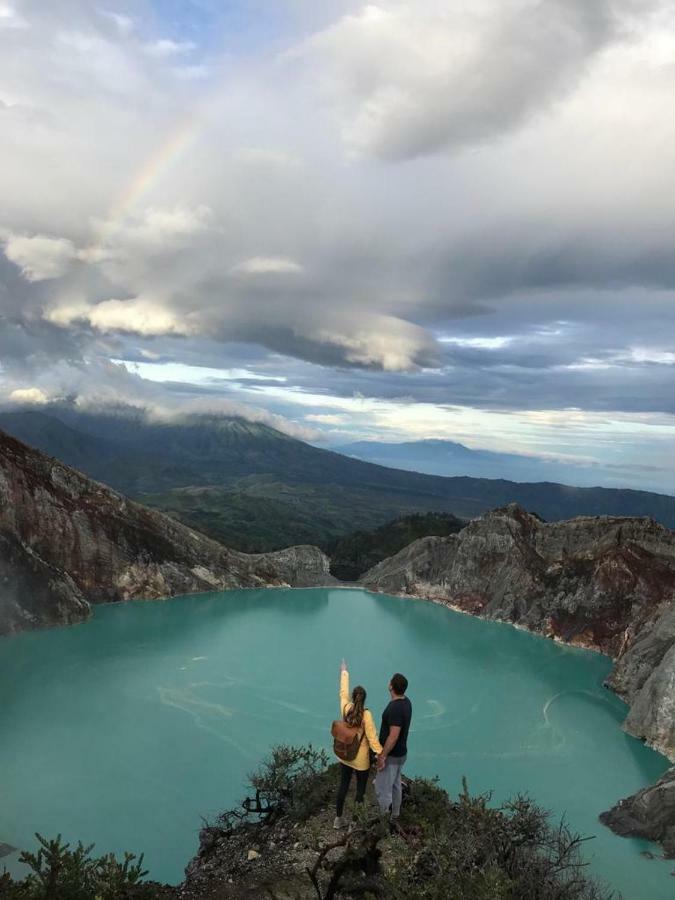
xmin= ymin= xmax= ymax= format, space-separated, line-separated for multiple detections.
xmin=362 ymin=504 xmax=675 ymax=661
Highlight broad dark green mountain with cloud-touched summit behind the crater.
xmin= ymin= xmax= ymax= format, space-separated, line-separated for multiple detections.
xmin=0 ymin=407 xmax=675 ymax=552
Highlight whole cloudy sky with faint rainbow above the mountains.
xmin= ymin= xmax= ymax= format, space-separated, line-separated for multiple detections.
xmin=0 ymin=0 xmax=675 ymax=493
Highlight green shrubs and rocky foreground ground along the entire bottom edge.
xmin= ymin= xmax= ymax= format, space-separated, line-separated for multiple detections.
xmin=0 ymin=746 xmax=613 ymax=900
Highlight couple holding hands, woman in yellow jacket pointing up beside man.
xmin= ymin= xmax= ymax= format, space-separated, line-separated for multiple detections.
xmin=334 ymin=659 xmax=412 ymax=829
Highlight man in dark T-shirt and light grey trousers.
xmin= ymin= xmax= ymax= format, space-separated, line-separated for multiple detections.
xmin=374 ymin=672 xmax=412 ymax=819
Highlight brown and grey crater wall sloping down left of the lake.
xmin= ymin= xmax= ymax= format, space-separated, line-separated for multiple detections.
xmin=0 ymin=432 xmax=333 ymax=634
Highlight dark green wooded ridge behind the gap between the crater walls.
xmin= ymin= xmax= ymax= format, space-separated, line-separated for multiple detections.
xmin=322 ymin=512 xmax=465 ymax=581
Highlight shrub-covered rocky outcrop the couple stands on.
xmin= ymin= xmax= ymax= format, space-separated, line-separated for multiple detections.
xmin=201 ymin=747 xmax=613 ymax=900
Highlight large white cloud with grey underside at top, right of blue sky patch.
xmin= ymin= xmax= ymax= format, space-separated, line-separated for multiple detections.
xmin=297 ymin=0 xmax=614 ymax=160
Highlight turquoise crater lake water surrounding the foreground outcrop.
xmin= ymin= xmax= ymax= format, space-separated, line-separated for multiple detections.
xmin=0 ymin=589 xmax=675 ymax=900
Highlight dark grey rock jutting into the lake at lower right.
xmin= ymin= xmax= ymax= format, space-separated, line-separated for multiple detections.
xmin=600 ymin=767 xmax=675 ymax=859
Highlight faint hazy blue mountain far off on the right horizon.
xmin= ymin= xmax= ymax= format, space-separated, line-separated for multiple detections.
xmin=334 ymin=440 xmax=651 ymax=487
